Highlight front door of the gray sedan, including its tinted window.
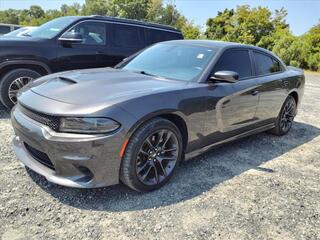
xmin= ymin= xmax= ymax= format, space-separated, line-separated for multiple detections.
xmin=206 ymin=49 xmax=260 ymax=145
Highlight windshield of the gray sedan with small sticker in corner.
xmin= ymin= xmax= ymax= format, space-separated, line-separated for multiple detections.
xmin=120 ymin=42 xmax=217 ymax=81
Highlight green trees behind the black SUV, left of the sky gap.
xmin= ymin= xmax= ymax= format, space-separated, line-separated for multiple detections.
xmin=0 ymin=0 xmax=200 ymax=38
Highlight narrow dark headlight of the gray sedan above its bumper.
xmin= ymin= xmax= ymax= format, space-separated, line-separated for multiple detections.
xmin=59 ymin=117 xmax=120 ymax=134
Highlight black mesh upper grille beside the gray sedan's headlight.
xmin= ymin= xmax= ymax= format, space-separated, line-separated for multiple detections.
xmin=19 ymin=104 xmax=60 ymax=131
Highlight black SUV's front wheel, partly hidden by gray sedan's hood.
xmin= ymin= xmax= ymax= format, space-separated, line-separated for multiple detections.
xmin=0 ymin=68 xmax=41 ymax=109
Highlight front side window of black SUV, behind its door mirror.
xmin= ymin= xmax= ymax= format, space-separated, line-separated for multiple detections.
xmin=69 ymin=21 xmax=106 ymax=45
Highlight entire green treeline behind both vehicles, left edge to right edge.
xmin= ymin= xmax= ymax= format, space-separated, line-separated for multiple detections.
xmin=0 ymin=0 xmax=320 ymax=71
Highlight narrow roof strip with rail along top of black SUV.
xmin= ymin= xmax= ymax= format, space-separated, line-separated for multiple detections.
xmin=82 ymin=15 xmax=181 ymax=33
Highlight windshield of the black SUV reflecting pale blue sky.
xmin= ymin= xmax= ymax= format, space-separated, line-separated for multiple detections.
xmin=27 ymin=17 xmax=77 ymax=39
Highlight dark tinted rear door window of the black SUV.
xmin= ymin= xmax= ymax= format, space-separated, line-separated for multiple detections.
xmin=113 ymin=24 xmax=141 ymax=48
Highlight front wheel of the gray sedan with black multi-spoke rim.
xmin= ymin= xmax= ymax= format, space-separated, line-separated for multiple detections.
xmin=120 ymin=118 xmax=183 ymax=192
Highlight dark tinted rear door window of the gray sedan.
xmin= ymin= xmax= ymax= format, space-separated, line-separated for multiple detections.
xmin=253 ymin=52 xmax=281 ymax=75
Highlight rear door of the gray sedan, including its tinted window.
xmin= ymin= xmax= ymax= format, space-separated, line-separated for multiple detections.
xmin=253 ymin=51 xmax=288 ymax=123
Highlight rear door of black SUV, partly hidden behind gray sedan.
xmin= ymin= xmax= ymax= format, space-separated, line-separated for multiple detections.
xmin=109 ymin=23 xmax=145 ymax=66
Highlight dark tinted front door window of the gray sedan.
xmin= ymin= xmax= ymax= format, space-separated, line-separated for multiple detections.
xmin=213 ymin=50 xmax=252 ymax=78
